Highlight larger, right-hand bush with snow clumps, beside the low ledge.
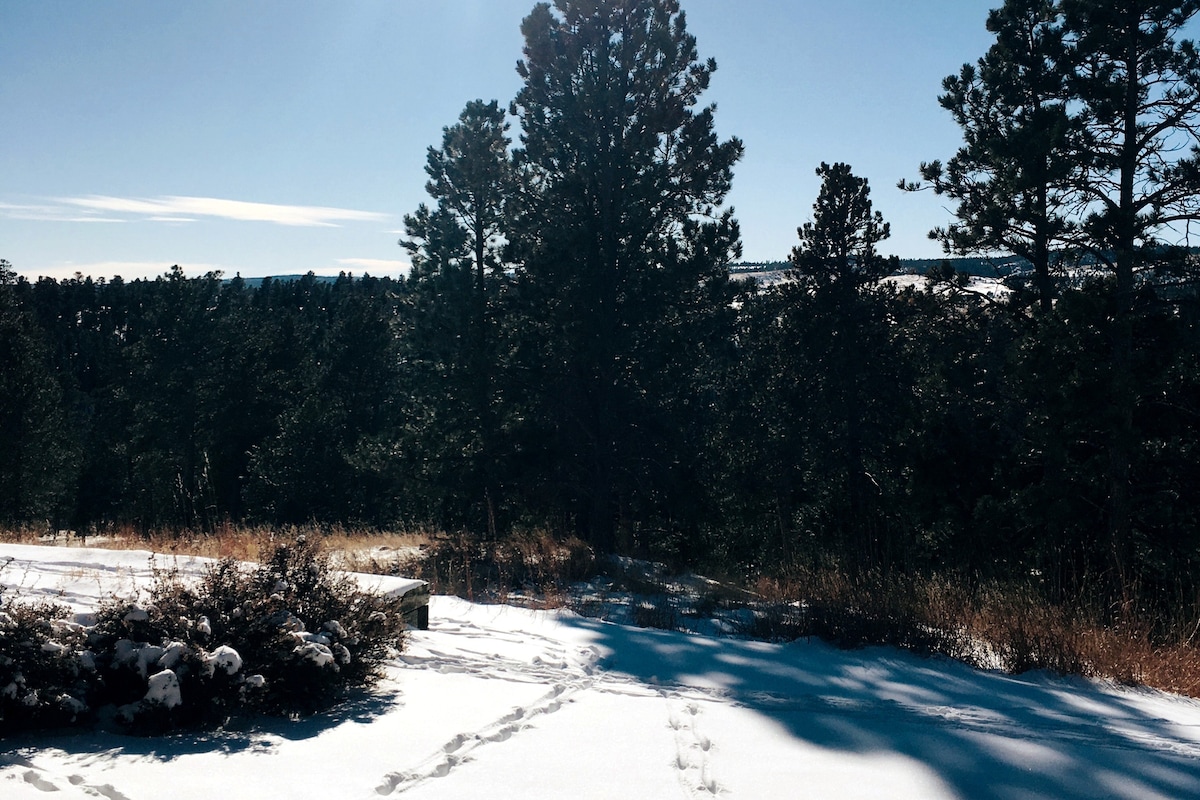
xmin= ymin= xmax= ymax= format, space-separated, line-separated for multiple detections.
xmin=91 ymin=540 xmax=404 ymax=733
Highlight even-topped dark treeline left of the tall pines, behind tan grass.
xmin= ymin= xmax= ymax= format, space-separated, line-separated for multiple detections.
xmin=0 ymin=265 xmax=397 ymax=530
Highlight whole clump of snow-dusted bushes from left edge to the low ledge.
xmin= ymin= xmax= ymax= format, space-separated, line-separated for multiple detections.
xmin=0 ymin=541 xmax=404 ymax=735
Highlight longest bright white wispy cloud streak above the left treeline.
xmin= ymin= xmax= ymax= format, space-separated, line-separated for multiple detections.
xmin=58 ymin=194 xmax=390 ymax=227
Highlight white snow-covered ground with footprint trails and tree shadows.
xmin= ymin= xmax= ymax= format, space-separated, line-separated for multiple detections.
xmin=7 ymin=545 xmax=1200 ymax=800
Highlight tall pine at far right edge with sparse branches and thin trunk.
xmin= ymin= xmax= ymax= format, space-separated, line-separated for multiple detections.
xmin=1061 ymin=0 xmax=1200 ymax=590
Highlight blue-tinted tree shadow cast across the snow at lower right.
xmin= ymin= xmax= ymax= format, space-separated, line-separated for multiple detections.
xmin=562 ymin=615 xmax=1200 ymax=800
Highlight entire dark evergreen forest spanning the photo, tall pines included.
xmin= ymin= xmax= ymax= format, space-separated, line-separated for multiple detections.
xmin=0 ymin=0 xmax=1200 ymax=606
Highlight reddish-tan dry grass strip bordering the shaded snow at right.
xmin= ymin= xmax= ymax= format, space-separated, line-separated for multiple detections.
xmin=755 ymin=570 xmax=1200 ymax=697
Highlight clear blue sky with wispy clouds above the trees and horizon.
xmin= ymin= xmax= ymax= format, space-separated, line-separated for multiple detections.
xmin=0 ymin=0 xmax=1000 ymax=279
